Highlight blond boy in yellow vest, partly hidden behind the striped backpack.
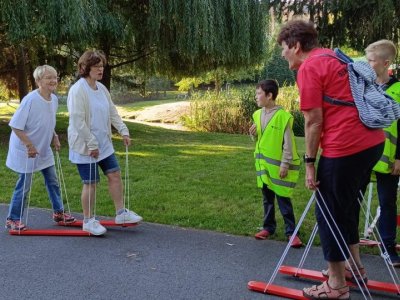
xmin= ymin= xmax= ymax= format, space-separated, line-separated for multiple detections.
xmin=365 ymin=40 xmax=400 ymax=267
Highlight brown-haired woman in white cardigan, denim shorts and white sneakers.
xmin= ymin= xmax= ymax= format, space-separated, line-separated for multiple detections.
xmin=68 ymin=51 xmax=142 ymax=235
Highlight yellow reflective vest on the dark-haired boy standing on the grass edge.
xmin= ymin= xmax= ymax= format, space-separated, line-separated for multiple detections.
xmin=253 ymin=109 xmax=300 ymax=198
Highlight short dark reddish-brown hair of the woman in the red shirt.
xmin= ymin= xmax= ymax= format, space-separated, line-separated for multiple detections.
xmin=277 ymin=20 xmax=318 ymax=52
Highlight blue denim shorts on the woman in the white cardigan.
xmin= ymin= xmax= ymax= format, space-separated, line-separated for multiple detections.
xmin=76 ymin=153 xmax=120 ymax=184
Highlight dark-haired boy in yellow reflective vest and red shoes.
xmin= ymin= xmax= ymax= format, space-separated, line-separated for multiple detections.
xmin=249 ymin=80 xmax=302 ymax=248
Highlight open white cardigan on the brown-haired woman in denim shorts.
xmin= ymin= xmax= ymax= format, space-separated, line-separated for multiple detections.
xmin=67 ymin=78 xmax=129 ymax=155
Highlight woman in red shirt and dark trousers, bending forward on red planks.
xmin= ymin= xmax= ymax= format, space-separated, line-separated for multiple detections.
xmin=278 ymin=20 xmax=385 ymax=299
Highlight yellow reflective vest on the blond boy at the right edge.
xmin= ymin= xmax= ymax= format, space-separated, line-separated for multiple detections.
xmin=373 ymin=82 xmax=400 ymax=174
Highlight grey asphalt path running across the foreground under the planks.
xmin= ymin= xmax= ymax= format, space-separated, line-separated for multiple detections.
xmin=0 ymin=205 xmax=396 ymax=300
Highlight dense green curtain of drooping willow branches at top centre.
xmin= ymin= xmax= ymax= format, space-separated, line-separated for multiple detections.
xmin=148 ymin=0 xmax=267 ymax=86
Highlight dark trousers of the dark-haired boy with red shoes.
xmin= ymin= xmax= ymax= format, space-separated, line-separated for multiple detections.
xmin=262 ymin=184 xmax=296 ymax=236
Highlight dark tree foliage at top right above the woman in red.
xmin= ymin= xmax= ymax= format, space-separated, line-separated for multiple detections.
xmin=270 ymin=0 xmax=400 ymax=51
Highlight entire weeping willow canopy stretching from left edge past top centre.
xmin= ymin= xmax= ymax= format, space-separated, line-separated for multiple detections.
xmin=0 ymin=0 xmax=267 ymax=97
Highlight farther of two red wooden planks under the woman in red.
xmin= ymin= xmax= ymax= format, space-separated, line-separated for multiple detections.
xmin=279 ymin=266 xmax=400 ymax=294
